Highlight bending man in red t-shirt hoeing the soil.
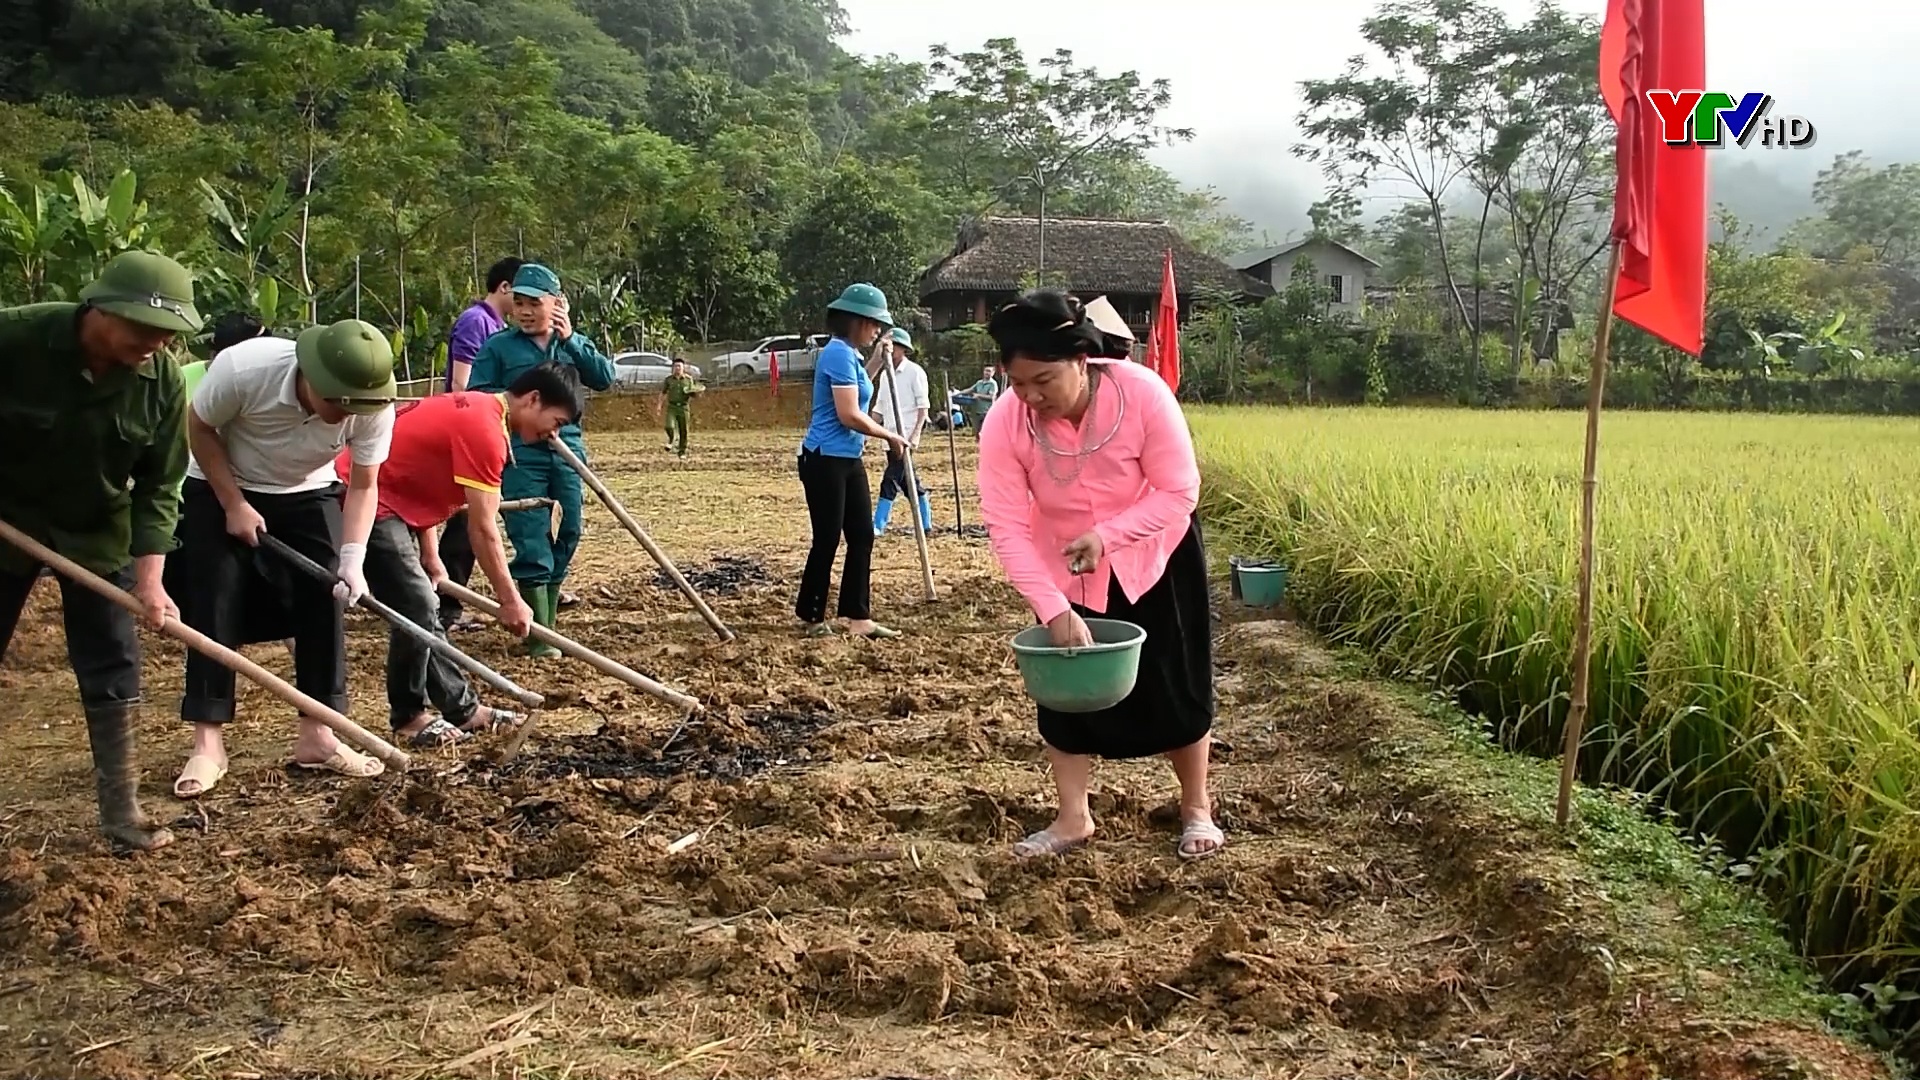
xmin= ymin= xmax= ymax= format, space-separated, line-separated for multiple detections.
xmin=338 ymin=363 xmax=580 ymax=748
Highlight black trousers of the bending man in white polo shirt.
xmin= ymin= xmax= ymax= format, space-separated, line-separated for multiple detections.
xmin=167 ymin=477 xmax=348 ymax=724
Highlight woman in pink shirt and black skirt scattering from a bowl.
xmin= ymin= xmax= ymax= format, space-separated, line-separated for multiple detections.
xmin=979 ymin=290 xmax=1227 ymax=859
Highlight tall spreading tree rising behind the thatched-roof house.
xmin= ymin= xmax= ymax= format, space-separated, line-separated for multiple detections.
xmin=924 ymin=38 xmax=1192 ymax=269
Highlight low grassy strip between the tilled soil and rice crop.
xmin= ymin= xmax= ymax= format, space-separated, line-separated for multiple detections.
xmin=1206 ymin=521 xmax=1910 ymax=1078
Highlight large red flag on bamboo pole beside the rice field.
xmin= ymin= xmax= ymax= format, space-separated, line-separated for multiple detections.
xmin=1599 ymin=0 xmax=1707 ymax=356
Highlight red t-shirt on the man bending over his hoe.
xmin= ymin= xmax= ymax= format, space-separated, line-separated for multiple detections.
xmin=334 ymin=390 xmax=507 ymax=528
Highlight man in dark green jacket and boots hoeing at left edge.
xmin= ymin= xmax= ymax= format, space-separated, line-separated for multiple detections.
xmin=0 ymin=252 xmax=200 ymax=849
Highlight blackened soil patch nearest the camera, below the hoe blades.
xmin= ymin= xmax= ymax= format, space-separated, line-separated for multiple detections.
xmin=495 ymin=709 xmax=835 ymax=780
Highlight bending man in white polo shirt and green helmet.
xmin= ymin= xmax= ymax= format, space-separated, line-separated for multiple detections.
xmin=167 ymin=319 xmax=396 ymax=799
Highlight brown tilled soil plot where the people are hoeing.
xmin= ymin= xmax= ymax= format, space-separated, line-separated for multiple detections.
xmin=0 ymin=432 xmax=1880 ymax=1080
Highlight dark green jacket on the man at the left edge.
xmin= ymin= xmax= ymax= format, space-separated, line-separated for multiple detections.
xmin=0 ymin=304 xmax=186 ymax=575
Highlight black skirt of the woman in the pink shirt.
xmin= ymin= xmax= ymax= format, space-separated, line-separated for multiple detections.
xmin=1039 ymin=515 xmax=1213 ymax=759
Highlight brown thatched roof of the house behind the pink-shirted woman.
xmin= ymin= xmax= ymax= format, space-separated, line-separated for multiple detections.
xmin=920 ymin=217 xmax=1273 ymax=330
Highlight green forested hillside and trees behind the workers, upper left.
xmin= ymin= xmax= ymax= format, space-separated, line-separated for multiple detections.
xmin=0 ymin=0 xmax=1244 ymax=359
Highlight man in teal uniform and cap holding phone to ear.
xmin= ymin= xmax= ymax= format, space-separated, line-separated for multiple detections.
xmin=467 ymin=263 xmax=614 ymax=645
